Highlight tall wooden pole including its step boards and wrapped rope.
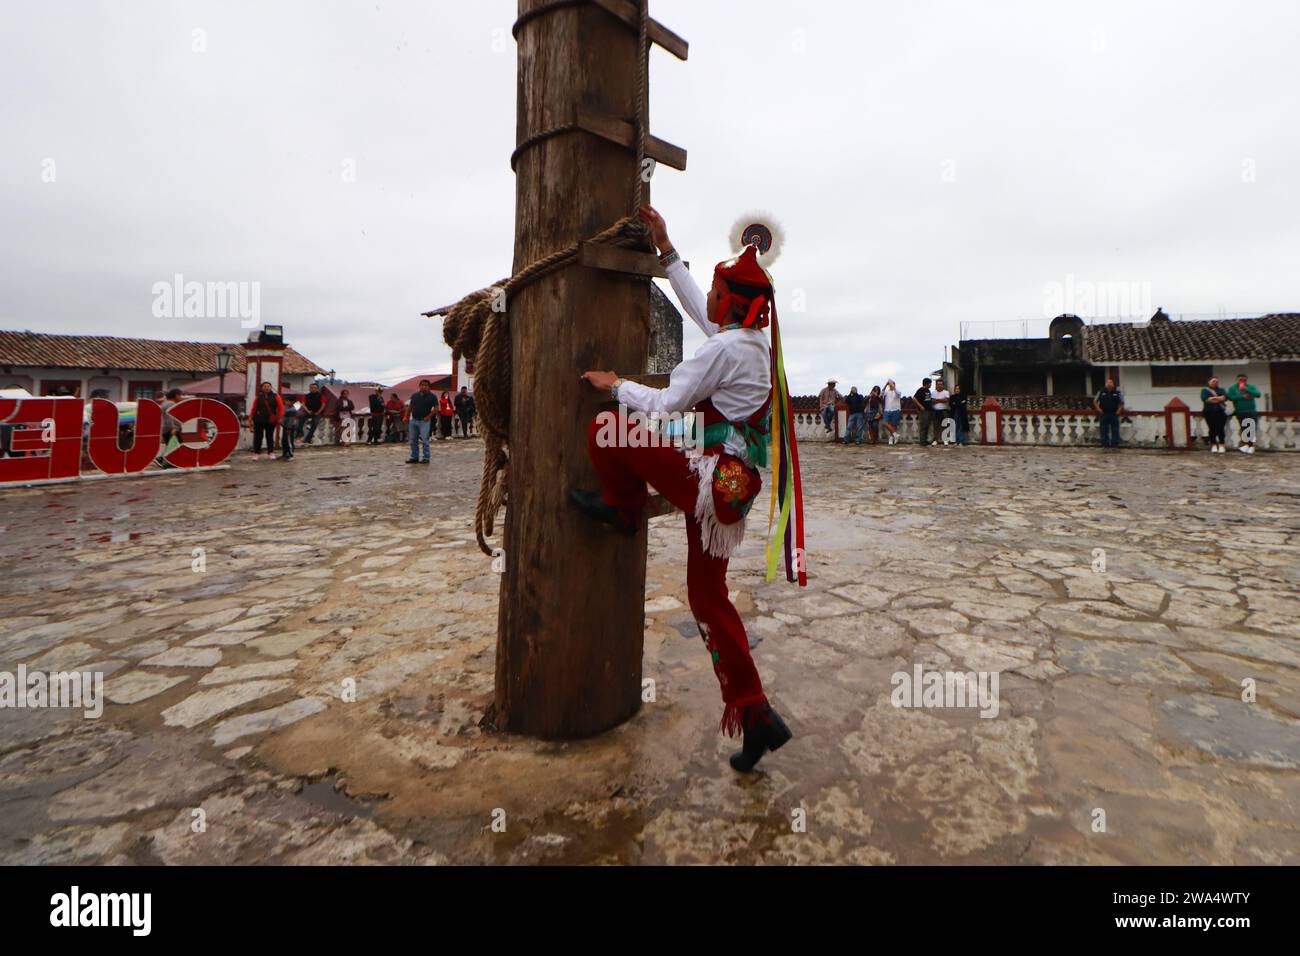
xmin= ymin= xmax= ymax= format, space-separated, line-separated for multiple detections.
xmin=426 ymin=0 xmax=686 ymax=739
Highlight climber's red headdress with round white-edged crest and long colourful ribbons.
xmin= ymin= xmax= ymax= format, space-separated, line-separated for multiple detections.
xmin=715 ymin=213 xmax=807 ymax=588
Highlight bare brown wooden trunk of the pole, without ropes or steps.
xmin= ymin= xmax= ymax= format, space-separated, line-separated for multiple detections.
xmin=494 ymin=0 xmax=660 ymax=739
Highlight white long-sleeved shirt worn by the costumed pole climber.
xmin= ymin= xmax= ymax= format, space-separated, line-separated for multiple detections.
xmin=619 ymin=261 xmax=772 ymax=460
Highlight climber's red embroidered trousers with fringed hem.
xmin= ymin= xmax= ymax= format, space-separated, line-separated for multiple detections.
xmin=588 ymin=412 xmax=767 ymax=736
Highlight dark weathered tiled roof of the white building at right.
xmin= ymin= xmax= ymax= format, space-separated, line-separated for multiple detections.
xmin=1083 ymin=312 xmax=1300 ymax=365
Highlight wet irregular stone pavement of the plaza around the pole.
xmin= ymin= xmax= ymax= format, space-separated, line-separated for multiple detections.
xmin=0 ymin=441 xmax=1300 ymax=864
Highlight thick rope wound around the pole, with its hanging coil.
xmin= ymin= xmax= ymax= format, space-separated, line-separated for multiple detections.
xmin=442 ymin=0 xmax=650 ymax=555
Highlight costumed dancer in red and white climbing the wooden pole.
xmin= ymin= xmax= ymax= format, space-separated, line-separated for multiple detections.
xmin=569 ymin=207 xmax=803 ymax=773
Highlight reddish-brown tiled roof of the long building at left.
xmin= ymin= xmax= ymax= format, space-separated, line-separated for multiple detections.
xmin=0 ymin=332 xmax=326 ymax=375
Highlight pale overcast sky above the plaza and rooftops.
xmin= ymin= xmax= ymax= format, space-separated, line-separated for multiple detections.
xmin=0 ymin=0 xmax=1300 ymax=393
